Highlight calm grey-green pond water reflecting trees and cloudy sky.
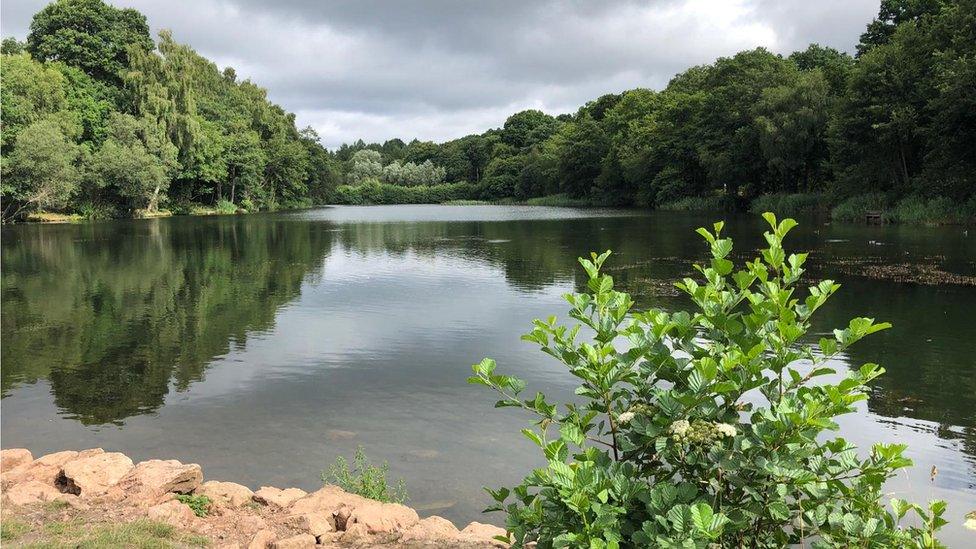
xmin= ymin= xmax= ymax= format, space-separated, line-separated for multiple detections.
xmin=0 ymin=206 xmax=976 ymax=544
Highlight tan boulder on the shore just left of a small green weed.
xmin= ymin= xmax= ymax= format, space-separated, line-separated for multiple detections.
xmin=113 ymin=459 xmax=203 ymax=502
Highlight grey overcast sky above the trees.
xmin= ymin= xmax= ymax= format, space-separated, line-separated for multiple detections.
xmin=0 ymin=0 xmax=879 ymax=147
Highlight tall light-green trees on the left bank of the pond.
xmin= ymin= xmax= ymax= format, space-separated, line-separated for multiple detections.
xmin=2 ymin=0 xmax=339 ymax=218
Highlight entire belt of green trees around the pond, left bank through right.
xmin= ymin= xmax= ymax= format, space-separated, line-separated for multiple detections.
xmin=2 ymin=0 xmax=976 ymax=222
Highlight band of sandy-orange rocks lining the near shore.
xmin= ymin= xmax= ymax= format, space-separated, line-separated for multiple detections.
xmin=0 ymin=448 xmax=508 ymax=549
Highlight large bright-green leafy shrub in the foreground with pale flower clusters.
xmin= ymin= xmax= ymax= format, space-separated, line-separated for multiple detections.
xmin=469 ymin=213 xmax=945 ymax=549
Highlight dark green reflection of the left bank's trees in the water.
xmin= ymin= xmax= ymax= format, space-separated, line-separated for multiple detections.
xmin=2 ymin=219 xmax=332 ymax=424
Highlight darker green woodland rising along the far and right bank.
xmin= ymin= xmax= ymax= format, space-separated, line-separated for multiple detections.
xmin=336 ymin=0 xmax=976 ymax=216
